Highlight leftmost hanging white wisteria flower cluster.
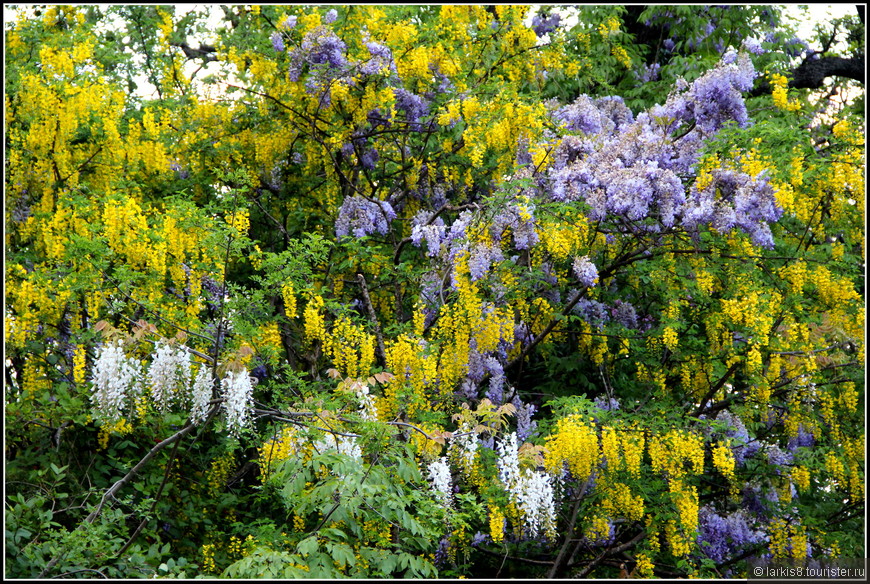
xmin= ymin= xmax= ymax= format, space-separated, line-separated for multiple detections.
xmin=91 ymin=342 xmax=142 ymax=422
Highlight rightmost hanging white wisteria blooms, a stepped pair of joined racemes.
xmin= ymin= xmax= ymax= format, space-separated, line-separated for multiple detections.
xmin=496 ymin=432 xmax=556 ymax=537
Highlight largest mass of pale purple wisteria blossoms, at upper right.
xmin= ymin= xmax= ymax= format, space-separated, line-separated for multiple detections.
xmin=548 ymin=51 xmax=782 ymax=247
